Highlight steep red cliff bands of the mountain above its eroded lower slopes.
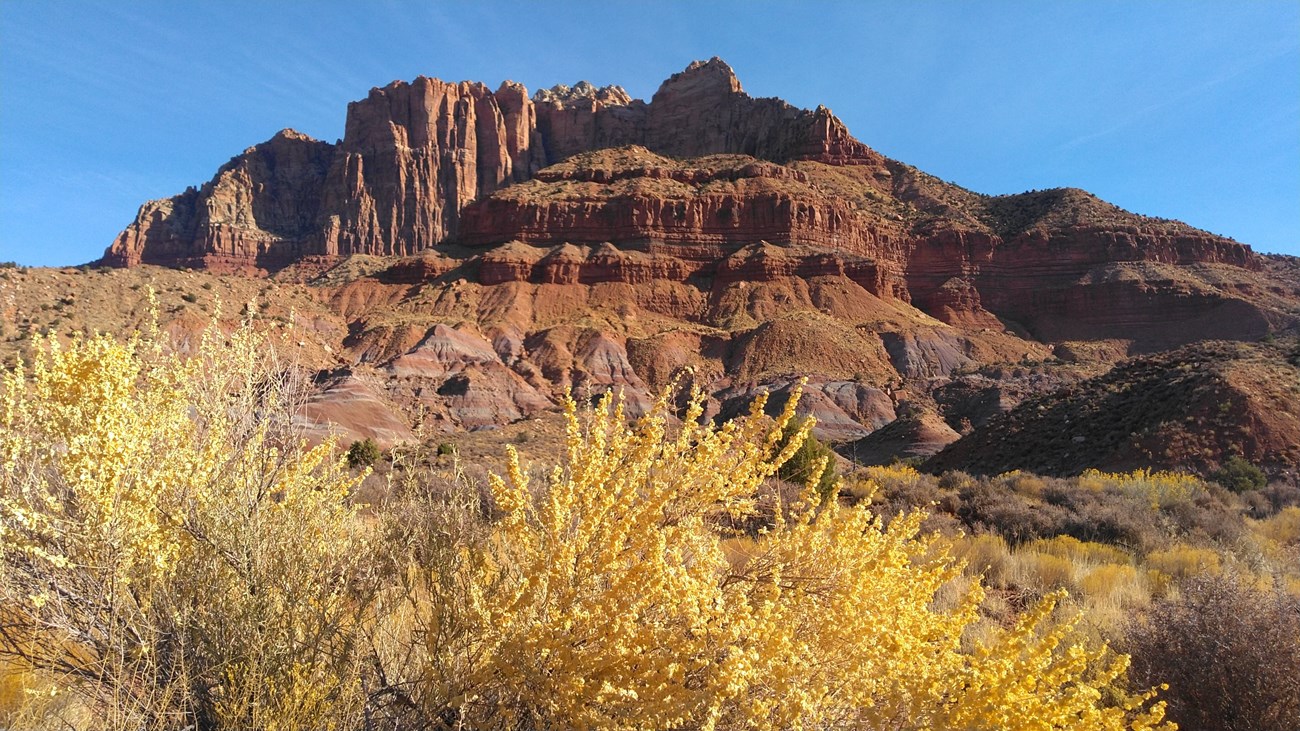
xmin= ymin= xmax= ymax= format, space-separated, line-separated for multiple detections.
xmin=104 ymin=59 xmax=1262 ymax=341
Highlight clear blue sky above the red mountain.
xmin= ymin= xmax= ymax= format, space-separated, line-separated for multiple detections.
xmin=0 ymin=0 xmax=1300 ymax=265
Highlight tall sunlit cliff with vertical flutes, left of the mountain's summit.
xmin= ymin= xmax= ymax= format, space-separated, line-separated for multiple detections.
xmin=309 ymin=77 xmax=541 ymax=256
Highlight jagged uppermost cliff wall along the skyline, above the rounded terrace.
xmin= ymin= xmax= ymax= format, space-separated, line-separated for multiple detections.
xmin=104 ymin=59 xmax=883 ymax=272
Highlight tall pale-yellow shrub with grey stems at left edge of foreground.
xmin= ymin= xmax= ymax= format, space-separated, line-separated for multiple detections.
xmin=0 ymin=318 xmax=365 ymax=730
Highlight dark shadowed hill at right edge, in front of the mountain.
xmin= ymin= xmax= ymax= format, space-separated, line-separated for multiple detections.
xmin=927 ymin=341 xmax=1300 ymax=475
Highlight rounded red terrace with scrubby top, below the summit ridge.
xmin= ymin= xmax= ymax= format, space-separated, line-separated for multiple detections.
xmin=459 ymin=147 xmax=902 ymax=258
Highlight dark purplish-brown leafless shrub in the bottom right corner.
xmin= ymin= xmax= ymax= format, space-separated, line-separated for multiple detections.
xmin=1123 ymin=576 xmax=1300 ymax=731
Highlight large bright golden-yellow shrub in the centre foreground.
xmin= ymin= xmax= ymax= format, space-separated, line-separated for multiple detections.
xmin=376 ymin=387 xmax=1161 ymax=730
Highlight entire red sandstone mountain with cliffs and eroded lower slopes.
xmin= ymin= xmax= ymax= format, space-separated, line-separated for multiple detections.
xmin=78 ymin=59 xmax=1300 ymax=473
